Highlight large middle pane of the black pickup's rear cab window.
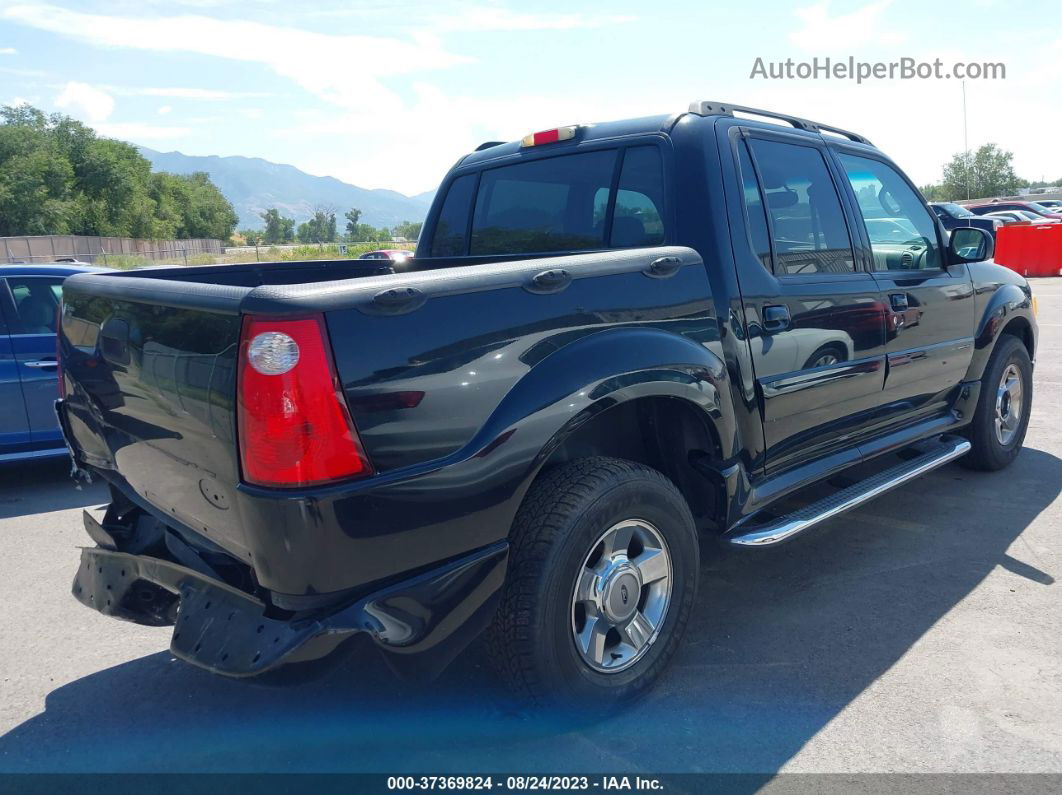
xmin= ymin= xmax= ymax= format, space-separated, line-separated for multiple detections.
xmin=470 ymin=150 xmax=616 ymax=254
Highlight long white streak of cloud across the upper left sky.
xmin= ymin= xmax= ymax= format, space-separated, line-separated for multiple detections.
xmin=3 ymin=4 xmax=469 ymax=113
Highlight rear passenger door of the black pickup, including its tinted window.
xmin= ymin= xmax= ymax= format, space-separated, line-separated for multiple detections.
xmin=731 ymin=127 xmax=885 ymax=471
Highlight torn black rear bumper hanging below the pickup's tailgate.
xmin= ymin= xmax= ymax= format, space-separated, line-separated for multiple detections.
xmin=72 ymin=542 xmax=509 ymax=676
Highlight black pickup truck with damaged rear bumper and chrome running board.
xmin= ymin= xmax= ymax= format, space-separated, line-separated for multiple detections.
xmin=58 ymin=102 xmax=1037 ymax=704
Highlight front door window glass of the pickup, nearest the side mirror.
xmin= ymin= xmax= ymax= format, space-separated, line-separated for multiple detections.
xmin=840 ymin=154 xmax=941 ymax=271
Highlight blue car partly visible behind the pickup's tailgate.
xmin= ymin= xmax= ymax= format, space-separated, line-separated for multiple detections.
xmin=0 ymin=264 xmax=105 ymax=462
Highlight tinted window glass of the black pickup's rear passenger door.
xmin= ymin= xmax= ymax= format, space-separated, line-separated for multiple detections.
xmin=751 ymin=138 xmax=855 ymax=276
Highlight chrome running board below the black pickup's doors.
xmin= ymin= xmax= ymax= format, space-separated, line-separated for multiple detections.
xmin=726 ymin=436 xmax=970 ymax=547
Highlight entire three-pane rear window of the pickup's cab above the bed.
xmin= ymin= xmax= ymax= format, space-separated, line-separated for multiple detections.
xmin=431 ymin=145 xmax=665 ymax=257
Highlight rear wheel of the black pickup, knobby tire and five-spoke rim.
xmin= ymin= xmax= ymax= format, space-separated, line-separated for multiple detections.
xmin=486 ymin=457 xmax=700 ymax=711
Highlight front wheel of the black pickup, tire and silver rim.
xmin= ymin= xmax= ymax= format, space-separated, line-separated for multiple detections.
xmin=959 ymin=334 xmax=1032 ymax=471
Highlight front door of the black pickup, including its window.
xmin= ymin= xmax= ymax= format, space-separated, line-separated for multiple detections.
xmin=837 ymin=148 xmax=976 ymax=421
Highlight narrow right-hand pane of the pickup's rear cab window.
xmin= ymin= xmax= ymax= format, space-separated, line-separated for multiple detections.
xmin=609 ymin=146 xmax=664 ymax=248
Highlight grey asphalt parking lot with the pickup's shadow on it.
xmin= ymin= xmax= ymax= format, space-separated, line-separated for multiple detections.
xmin=0 ymin=279 xmax=1062 ymax=773
